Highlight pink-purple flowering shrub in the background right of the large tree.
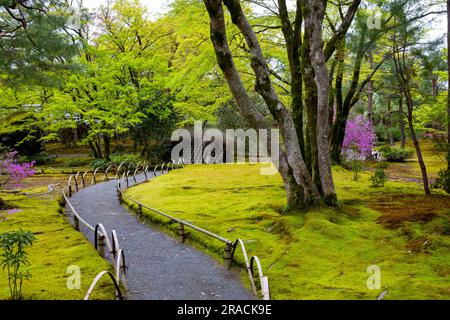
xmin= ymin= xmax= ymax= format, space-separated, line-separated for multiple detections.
xmin=342 ymin=116 xmax=377 ymax=160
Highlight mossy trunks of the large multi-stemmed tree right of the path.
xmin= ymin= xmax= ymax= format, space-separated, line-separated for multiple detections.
xmin=204 ymin=0 xmax=361 ymax=209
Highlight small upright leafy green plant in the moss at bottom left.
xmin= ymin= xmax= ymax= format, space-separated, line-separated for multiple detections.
xmin=0 ymin=231 xmax=36 ymax=300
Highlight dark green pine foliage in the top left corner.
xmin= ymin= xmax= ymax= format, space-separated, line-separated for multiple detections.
xmin=0 ymin=0 xmax=78 ymax=86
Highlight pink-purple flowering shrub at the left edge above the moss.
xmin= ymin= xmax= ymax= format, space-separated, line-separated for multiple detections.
xmin=0 ymin=152 xmax=36 ymax=187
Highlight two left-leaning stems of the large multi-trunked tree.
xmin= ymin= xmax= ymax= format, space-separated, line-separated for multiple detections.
xmin=204 ymin=0 xmax=320 ymax=210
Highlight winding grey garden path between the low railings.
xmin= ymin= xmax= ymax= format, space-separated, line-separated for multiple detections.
xmin=71 ymin=175 xmax=255 ymax=300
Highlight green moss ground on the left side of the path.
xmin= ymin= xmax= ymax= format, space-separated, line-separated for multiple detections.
xmin=0 ymin=188 xmax=114 ymax=300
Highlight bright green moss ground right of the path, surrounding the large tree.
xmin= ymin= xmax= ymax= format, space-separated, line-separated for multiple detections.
xmin=127 ymin=165 xmax=450 ymax=300
